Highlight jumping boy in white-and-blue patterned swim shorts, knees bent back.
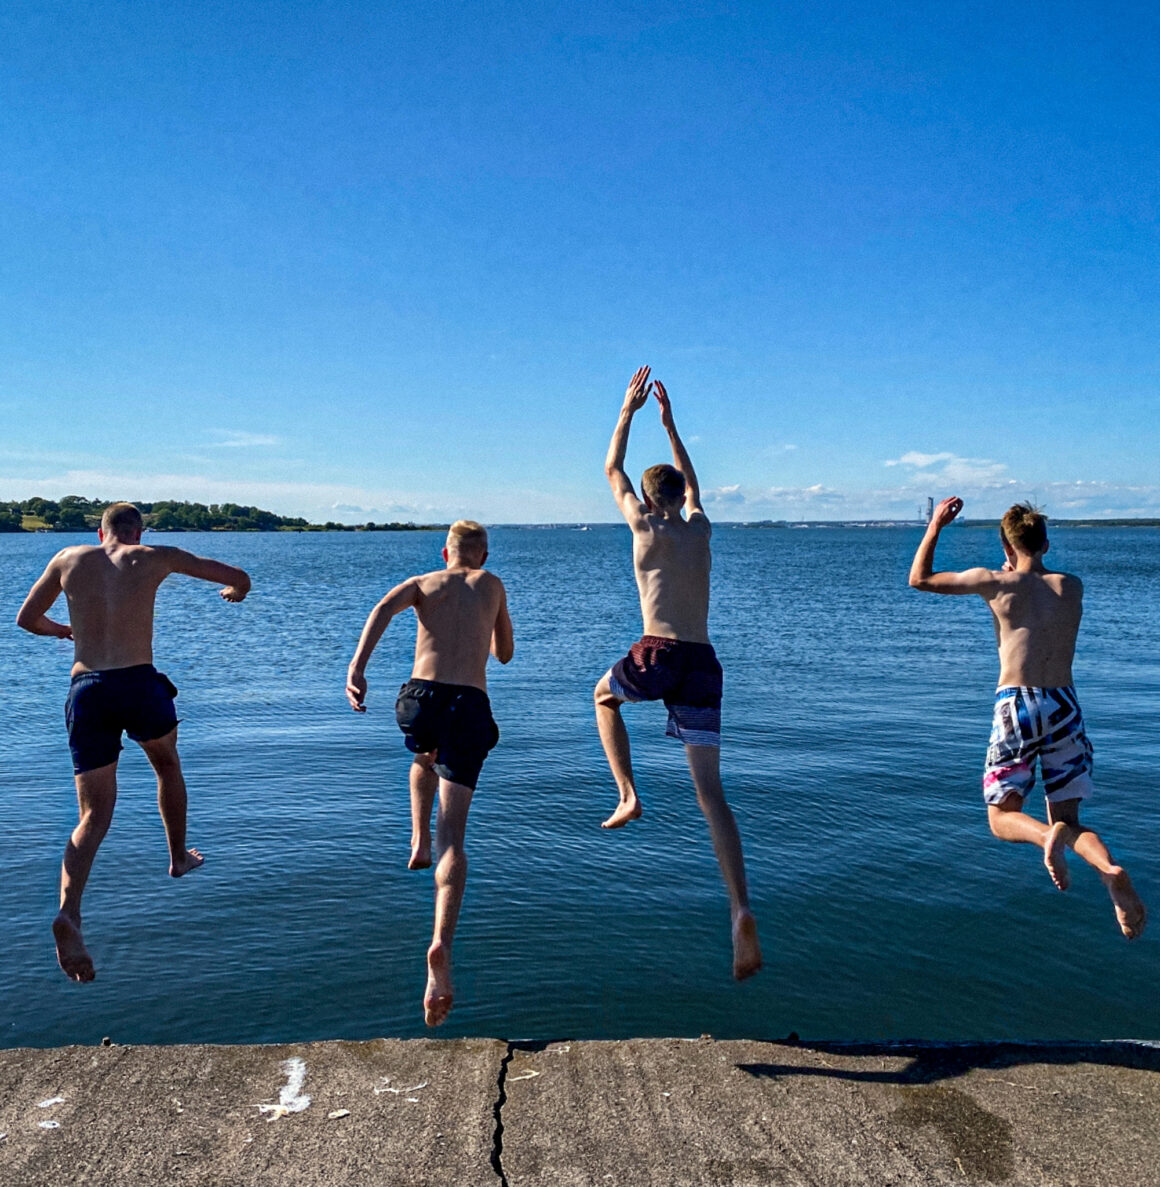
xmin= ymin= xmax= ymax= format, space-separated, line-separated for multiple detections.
xmin=911 ymin=499 xmax=1147 ymax=940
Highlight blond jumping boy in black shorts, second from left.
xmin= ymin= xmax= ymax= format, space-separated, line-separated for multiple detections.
xmin=347 ymin=520 xmax=515 ymax=1027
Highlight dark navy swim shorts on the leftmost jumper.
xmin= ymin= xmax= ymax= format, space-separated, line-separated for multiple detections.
xmin=64 ymin=664 xmax=177 ymax=775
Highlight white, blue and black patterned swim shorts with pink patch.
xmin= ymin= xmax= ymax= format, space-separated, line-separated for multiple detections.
xmin=983 ymin=685 xmax=1092 ymax=804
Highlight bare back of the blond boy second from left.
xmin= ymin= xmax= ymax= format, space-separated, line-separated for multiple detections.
xmin=407 ymin=567 xmax=506 ymax=691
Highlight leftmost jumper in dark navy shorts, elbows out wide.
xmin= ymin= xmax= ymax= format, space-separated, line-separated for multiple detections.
xmin=17 ymin=503 xmax=249 ymax=980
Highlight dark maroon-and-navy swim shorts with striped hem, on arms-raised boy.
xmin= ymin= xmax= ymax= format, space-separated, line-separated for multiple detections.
xmin=608 ymin=635 xmax=723 ymax=747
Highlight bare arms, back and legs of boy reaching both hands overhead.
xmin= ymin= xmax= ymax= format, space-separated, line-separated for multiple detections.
xmin=595 ymin=367 xmax=761 ymax=980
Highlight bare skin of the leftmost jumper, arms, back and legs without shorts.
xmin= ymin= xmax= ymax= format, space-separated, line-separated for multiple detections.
xmin=17 ymin=527 xmax=249 ymax=982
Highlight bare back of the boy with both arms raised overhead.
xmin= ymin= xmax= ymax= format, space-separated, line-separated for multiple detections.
xmin=630 ymin=512 xmax=712 ymax=643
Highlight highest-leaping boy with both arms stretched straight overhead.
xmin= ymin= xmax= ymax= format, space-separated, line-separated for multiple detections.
xmin=596 ymin=367 xmax=761 ymax=980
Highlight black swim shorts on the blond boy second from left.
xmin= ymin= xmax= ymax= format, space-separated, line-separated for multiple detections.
xmin=394 ymin=680 xmax=500 ymax=791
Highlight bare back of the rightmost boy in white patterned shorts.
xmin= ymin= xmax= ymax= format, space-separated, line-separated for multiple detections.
xmin=983 ymin=569 xmax=1083 ymax=688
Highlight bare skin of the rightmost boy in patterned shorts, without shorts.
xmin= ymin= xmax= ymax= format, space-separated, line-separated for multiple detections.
xmin=909 ymin=497 xmax=1147 ymax=940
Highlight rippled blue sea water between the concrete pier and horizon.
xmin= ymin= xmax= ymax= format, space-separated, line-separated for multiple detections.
xmin=0 ymin=526 xmax=1160 ymax=1046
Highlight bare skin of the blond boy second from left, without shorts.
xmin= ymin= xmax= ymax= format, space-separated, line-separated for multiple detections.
xmin=347 ymin=537 xmax=515 ymax=1027
